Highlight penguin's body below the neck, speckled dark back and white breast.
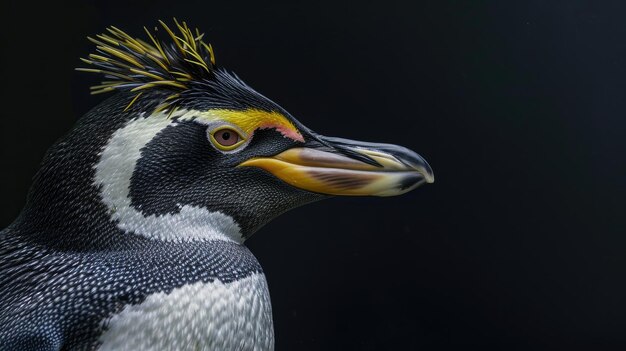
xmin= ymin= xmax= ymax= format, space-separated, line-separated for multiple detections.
xmin=0 ymin=233 xmax=274 ymax=350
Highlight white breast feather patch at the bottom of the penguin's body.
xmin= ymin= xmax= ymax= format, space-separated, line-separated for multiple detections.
xmin=99 ymin=274 xmax=274 ymax=351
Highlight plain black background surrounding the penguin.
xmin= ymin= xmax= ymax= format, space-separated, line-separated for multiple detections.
xmin=0 ymin=0 xmax=626 ymax=350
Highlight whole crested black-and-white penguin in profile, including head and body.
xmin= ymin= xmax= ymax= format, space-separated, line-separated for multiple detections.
xmin=0 ymin=20 xmax=434 ymax=351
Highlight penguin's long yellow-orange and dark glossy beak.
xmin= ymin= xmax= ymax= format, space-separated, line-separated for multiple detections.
xmin=240 ymin=136 xmax=435 ymax=196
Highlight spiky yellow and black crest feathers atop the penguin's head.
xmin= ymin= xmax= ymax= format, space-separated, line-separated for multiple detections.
xmin=77 ymin=18 xmax=215 ymax=110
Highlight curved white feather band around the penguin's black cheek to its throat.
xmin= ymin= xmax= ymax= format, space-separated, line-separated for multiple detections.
xmin=93 ymin=113 xmax=243 ymax=242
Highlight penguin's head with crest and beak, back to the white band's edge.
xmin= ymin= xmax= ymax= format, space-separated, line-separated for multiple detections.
xmin=41 ymin=22 xmax=434 ymax=242
